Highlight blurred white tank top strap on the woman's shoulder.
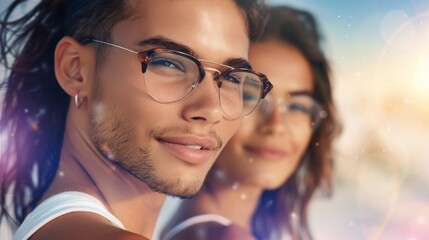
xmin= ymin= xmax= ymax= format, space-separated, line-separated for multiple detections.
xmin=162 ymin=214 xmax=232 ymax=240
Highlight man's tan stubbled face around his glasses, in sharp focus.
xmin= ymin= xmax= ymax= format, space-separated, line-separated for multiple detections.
xmin=89 ymin=0 xmax=249 ymax=197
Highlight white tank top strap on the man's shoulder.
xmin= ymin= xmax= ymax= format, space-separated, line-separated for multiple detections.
xmin=13 ymin=192 xmax=125 ymax=240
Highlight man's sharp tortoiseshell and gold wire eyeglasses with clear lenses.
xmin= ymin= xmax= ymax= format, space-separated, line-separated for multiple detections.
xmin=81 ymin=38 xmax=273 ymax=120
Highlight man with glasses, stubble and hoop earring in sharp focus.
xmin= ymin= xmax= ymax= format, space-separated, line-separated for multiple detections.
xmin=0 ymin=0 xmax=271 ymax=239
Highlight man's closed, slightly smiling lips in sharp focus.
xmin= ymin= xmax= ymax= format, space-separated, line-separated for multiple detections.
xmin=157 ymin=135 xmax=220 ymax=164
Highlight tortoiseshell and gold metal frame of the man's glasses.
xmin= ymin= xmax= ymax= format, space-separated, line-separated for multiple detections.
xmin=80 ymin=38 xmax=274 ymax=119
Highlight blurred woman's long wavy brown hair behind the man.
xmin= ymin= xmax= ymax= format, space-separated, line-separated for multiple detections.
xmin=252 ymin=6 xmax=340 ymax=240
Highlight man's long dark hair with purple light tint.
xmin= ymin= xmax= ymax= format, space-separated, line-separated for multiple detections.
xmin=0 ymin=0 xmax=263 ymax=224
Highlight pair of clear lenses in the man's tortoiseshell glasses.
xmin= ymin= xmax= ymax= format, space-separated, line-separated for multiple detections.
xmin=140 ymin=52 xmax=263 ymax=119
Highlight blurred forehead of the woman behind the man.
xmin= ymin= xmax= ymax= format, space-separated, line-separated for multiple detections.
xmin=249 ymin=41 xmax=314 ymax=95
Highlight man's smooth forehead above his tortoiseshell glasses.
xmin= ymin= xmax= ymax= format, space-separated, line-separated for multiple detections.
xmin=112 ymin=0 xmax=249 ymax=62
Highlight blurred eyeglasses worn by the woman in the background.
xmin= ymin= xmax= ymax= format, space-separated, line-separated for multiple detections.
xmin=257 ymin=95 xmax=328 ymax=130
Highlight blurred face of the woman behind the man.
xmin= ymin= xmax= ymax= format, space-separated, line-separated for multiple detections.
xmin=215 ymin=41 xmax=314 ymax=189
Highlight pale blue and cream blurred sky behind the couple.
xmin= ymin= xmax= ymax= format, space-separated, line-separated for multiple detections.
xmin=0 ymin=0 xmax=429 ymax=240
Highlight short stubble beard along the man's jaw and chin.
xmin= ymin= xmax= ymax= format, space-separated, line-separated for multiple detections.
xmin=89 ymin=101 xmax=202 ymax=199
